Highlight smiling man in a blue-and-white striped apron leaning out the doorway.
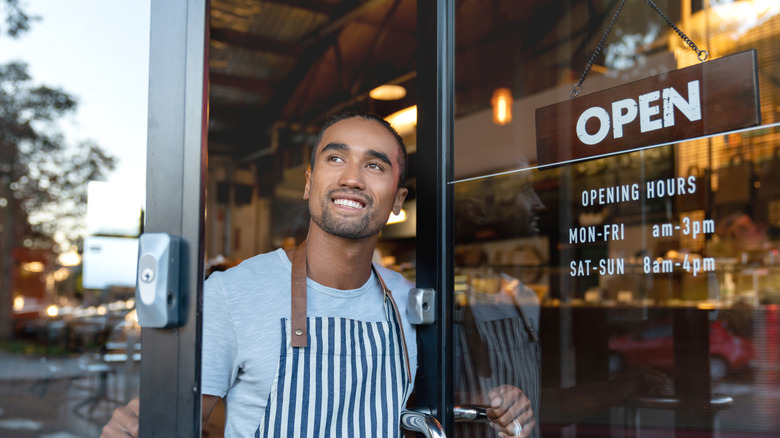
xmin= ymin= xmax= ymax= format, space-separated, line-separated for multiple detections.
xmin=103 ymin=113 xmax=525 ymax=437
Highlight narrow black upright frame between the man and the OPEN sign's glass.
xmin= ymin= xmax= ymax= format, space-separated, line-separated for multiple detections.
xmin=415 ymin=0 xmax=455 ymax=431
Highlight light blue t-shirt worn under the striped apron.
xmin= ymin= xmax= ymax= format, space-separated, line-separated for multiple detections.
xmin=201 ymin=249 xmax=417 ymax=437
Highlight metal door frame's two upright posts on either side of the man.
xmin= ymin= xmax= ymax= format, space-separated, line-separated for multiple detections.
xmin=140 ymin=0 xmax=455 ymax=437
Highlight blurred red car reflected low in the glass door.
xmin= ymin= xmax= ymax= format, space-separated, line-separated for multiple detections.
xmin=609 ymin=321 xmax=754 ymax=381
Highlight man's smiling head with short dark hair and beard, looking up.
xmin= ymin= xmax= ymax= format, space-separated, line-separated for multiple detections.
xmin=303 ymin=117 xmax=407 ymax=239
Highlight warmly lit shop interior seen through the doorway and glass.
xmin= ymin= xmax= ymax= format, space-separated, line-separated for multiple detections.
xmin=206 ymin=0 xmax=780 ymax=433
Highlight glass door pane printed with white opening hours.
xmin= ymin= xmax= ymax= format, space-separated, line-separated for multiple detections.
xmin=448 ymin=1 xmax=780 ymax=437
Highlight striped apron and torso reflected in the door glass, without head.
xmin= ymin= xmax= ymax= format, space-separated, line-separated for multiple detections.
xmin=455 ymin=268 xmax=541 ymax=437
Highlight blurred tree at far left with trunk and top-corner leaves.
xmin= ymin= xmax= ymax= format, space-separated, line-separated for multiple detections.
xmin=0 ymin=0 xmax=114 ymax=340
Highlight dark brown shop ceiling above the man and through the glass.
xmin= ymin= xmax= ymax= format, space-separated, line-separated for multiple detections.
xmin=209 ymin=0 xmax=616 ymax=164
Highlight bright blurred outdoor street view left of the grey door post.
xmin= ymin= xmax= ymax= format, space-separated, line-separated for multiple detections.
xmin=0 ymin=0 xmax=149 ymax=437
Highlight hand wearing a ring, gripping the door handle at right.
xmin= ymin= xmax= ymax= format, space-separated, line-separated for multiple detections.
xmin=487 ymin=385 xmax=536 ymax=438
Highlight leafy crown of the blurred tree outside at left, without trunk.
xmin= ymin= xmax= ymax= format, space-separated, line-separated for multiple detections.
xmin=0 ymin=62 xmax=114 ymax=246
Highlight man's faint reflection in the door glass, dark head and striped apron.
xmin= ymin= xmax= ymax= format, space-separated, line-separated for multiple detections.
xmin=455 ymin=172 xmax=544 ymax=437
